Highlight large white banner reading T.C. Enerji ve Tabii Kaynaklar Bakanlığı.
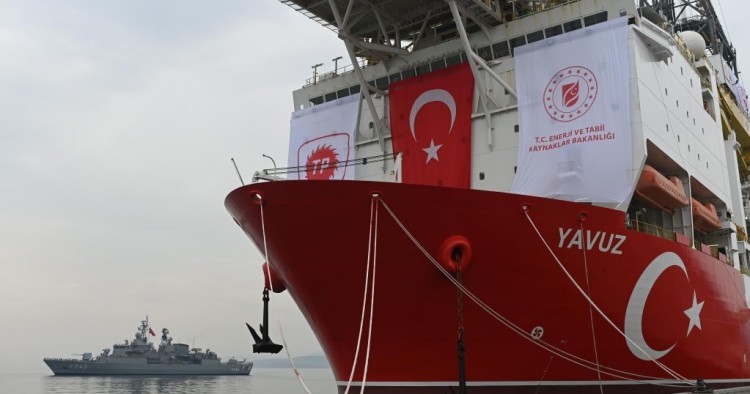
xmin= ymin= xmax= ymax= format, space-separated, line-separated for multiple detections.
xmin=512 ymin=18 xmax=634 ymax=204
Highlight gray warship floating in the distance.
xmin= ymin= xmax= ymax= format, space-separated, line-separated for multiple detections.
xmin=44 ymin=316 xmax=253 ymax=375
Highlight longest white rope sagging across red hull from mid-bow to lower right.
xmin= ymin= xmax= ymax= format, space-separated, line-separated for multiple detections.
xmin=380 ymin=198 xmax=692 ymax=388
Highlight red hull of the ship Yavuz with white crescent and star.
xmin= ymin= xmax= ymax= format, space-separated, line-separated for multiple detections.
xmin=225 ymin=181 xmax=750 ymax=393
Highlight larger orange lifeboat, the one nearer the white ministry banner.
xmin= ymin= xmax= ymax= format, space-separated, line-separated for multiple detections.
xmin=635 ymin=164 xmax=689 ymax=212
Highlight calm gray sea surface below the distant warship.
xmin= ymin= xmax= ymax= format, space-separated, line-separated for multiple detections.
xmin=0 ymin=368 xmax=336 ymax=394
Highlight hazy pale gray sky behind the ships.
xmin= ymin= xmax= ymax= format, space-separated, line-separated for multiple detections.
xmin=0 ymin=0 xmax=750 ymax=372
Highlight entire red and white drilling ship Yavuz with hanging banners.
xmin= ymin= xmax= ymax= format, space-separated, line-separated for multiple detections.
xmin=225 ymin=0 xmax=750 ymax=394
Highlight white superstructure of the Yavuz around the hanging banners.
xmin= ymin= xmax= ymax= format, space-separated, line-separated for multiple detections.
xmin=268 ymin=0 xmax=750 ymax=269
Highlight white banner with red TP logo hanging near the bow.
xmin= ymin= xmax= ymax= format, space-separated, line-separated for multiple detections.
xmin=289 ymin=95 xmax=359 ymax=180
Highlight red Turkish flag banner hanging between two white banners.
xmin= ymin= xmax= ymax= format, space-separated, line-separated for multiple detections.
xmin=389 ymin=63 xmax=474 ymax=188
